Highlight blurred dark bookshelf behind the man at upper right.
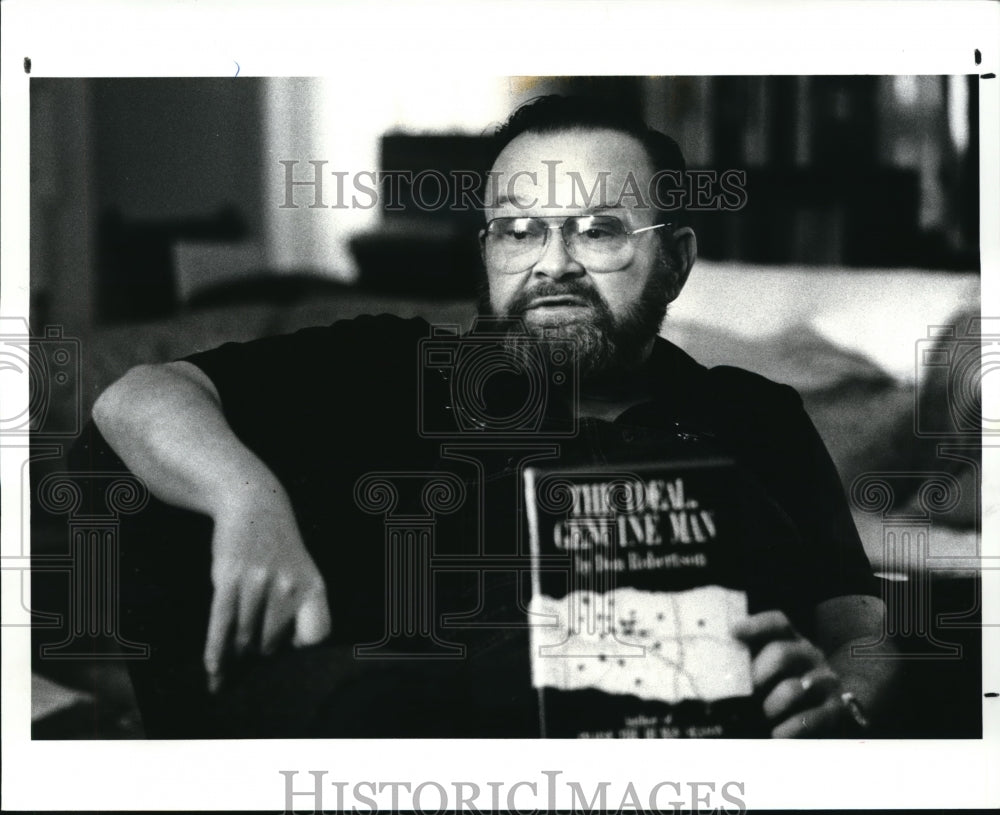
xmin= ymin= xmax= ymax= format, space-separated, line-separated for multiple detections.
xmin=642 ymin=76 xmax=979 ymax=271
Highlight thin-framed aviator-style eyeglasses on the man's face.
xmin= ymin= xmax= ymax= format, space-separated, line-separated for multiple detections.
xmin=483 ymin=215 xmax=670 ymax=274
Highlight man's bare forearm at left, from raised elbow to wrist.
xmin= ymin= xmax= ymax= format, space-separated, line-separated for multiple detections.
xmin=93 ymin=363 xmax=280 ymax=517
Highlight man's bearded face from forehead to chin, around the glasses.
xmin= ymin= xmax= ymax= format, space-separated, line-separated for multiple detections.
xmin=484 ymin=129 xmax=675 ymax=375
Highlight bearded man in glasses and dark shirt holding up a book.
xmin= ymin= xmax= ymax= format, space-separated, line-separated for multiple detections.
xmin=94 ymin=97 xmax=891 ymax=737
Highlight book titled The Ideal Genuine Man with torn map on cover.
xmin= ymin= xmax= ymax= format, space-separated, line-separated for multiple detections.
xmin=525 ymin=459 xmax=766 ymax=738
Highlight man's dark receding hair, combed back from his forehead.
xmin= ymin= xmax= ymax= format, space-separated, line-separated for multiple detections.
xmin=493 ymin=94 xmax=687 ymax=226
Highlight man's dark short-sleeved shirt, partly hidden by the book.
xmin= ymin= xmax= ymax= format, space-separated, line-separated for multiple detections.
xmin=187 ymin=315 xmax=877 ymax=735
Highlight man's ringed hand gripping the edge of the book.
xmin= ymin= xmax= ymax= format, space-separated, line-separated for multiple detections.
xmin=733 ymin=611 xmax=853 ymax=738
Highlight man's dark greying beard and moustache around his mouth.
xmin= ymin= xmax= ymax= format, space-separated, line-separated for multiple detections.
xmin=480 ymin=263 xmax=670 ymax=381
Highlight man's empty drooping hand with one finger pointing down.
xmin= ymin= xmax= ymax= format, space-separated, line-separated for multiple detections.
xmin=205 ymin=488 xmax=330 ymax=692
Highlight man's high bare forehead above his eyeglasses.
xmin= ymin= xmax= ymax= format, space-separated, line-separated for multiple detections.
xmin=487 ymin=128 xmax=653 ymax=215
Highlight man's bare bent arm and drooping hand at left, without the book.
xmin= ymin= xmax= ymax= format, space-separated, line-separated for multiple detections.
xmin=94 ymin=362 xmax=330 ymax=688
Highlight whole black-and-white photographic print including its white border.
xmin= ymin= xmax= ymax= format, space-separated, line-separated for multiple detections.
xmin=0 ymin=3 xmax=1000 ymax=812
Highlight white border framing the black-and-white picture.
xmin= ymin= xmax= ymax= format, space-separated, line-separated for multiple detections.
xmin=0 ymin=0 xmax=1000 ymax=811
